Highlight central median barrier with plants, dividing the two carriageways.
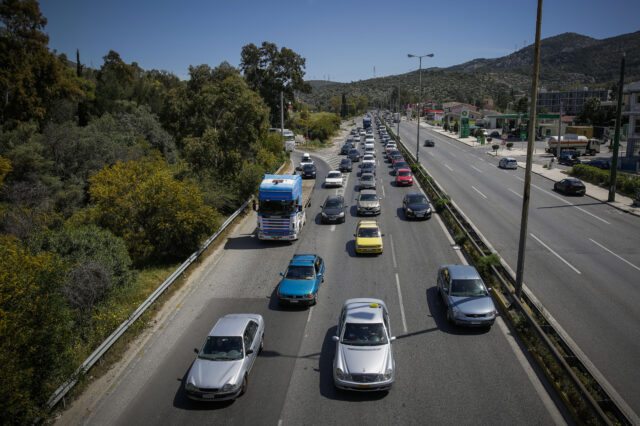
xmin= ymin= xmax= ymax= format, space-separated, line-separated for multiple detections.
xmin=383 ymin=116 xmax=632 ymax=425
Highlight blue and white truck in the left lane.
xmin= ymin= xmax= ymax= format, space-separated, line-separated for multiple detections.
xmin=257 ymin=175 xmax=315 ymax=241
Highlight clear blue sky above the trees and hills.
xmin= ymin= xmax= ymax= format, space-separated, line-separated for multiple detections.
xmin=40 ymin=0 xmax=640 ymax=82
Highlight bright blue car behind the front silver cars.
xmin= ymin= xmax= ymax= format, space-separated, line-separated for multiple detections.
xmin=276 ymin=254 xmax=325 ymax=305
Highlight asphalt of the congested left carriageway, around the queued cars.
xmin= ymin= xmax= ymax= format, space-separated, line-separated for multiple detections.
xmin=70 ymin=120 xmax=565 ymax=425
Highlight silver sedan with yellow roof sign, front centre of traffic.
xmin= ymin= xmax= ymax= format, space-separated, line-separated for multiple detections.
xmin=332 ymin=298 xmax=395 ymax=392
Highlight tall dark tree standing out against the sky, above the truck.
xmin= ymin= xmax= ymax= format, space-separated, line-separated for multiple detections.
xmin=240 ymin=41 xmax=310 ymax=127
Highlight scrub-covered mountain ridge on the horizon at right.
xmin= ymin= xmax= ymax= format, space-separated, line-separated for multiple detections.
xmin=301 ymin=31 xmax=640 ymax=107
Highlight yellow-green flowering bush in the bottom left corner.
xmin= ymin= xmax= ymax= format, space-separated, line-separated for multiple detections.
xmin=0 ymin=235 xmax=73 ymax=424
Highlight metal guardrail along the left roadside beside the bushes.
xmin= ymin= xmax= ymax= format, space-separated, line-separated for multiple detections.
xmin=47 ymin=160 xmax=288 ymax=408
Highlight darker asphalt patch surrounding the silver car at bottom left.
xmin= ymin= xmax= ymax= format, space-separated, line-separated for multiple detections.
xmin=116 ymin=298 xmax=307 ymax=425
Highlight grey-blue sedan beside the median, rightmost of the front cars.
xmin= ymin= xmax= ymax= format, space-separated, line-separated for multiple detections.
xmin=437 ymin=265 xmax=496 ymax=327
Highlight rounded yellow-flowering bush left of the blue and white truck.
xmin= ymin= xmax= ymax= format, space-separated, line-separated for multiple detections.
xmin=71 ymin=156 xmax=218 ymax=265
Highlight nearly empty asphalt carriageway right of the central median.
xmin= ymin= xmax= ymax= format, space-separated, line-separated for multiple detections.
xmin=400 ymin=118 xmax=640 ymax=413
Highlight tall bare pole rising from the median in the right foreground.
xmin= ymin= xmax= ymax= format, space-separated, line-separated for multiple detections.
xmin=516 ymin=0 xmax=542 ymax=297
